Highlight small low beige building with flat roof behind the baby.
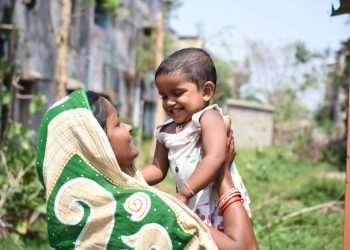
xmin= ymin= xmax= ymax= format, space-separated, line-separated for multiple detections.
xmin=226 ymin=99 xmax=275 ymax=148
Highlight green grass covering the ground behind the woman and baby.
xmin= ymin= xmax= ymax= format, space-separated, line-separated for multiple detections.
xmin=0 ymin=144 xmax=345 ymax=250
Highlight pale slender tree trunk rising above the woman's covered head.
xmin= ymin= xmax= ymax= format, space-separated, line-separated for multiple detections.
xmin=55 ymin=0 xmax=72 ymax=100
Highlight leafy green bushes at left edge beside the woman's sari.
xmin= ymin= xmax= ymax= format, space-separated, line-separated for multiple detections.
xmin=0 ymin=94 xmax=46 ymax=244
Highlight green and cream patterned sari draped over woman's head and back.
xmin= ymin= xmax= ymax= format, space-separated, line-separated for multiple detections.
xmin=36 ymin=90 xmax=216 ymax=250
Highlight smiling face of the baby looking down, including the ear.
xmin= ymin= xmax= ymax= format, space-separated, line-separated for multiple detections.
xmin=156 ymin=73 xmax=207 ymax=125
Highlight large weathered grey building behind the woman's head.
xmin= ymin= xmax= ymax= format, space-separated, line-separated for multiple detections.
xmin=0 ymin=0 xmax=171 ymax=134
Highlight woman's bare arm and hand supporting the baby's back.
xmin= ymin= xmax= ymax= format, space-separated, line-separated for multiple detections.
xmin=208 ymin=117 xmax=258 ymax=250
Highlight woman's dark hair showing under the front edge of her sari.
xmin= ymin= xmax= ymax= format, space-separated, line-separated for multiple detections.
xmin=86 ymin=90 xmax=107 ymax=130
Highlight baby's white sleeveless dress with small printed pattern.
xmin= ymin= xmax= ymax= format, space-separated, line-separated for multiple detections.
xmin=155 ymin=104 xmax=251 ymax=229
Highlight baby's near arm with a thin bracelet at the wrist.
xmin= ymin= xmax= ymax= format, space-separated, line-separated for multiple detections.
xmin=177 ymin=109 xmax=227 ymax=204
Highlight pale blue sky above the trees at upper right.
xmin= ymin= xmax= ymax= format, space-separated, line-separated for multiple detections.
xmin=170 ymin=0 xmax=350 ymax=62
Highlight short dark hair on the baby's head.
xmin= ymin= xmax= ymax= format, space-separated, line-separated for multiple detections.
xmin=155 ymin=48 xmax=216 ymax=88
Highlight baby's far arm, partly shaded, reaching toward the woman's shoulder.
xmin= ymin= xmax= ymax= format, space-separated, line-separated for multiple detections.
xmin=142 ymin=141 xmax=169 ymax=186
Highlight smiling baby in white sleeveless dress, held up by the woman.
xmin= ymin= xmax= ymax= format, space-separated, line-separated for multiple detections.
xmin=142 ymin=48 xmax=250 ymax=229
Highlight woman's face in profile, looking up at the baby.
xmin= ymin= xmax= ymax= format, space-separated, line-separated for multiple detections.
xmin=105 ymin=100 xmax=139 ymax=170
